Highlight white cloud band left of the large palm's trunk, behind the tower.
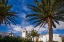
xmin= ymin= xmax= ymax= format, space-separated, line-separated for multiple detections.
xmin=8 ymin=25 xmax=47 ymax=33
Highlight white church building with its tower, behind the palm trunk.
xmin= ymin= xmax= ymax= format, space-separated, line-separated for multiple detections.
xmin=22 ymin=29 xmax=62 ymax=42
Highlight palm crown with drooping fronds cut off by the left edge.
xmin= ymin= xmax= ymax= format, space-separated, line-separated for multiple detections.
xmin=0 ymin=0 xmax=17 ymax=25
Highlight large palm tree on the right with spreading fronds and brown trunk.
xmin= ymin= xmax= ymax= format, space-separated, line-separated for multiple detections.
xmin=26 ymin=0 xmax=64 ymax=42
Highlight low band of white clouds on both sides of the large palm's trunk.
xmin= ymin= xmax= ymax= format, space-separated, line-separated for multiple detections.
xmin=6 ymin=21 xmax=64 ymax=34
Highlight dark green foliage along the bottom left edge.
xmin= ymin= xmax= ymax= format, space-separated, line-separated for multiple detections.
xmin=0 ymin=36 xmax=31 ymax=42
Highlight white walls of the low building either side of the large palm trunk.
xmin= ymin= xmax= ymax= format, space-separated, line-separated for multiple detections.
xmin=33 ymin=34 xmax=62 ymax=42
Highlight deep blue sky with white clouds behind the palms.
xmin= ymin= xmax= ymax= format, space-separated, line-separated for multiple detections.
xmin=0 ymin=0 xmax=64 ymax=36
